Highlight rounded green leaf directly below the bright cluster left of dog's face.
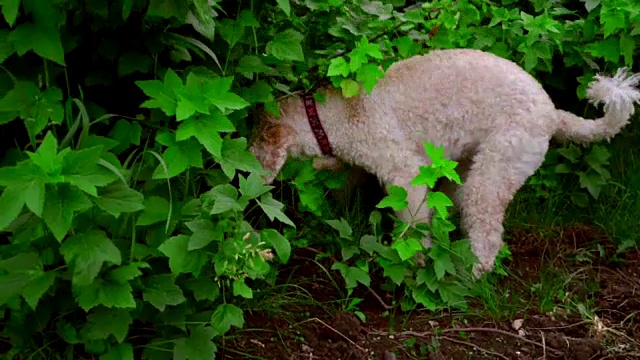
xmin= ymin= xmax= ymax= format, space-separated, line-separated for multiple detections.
xmin=153 ymin=139 xmax=203 ymax=179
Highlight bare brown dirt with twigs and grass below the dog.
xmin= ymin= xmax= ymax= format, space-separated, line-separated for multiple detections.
xmin=219 ymin=227 xmax=640 ymax=360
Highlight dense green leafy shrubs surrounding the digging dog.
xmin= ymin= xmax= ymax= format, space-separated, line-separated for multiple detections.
xmin=0 ymin=0 xmax=640 ymax=360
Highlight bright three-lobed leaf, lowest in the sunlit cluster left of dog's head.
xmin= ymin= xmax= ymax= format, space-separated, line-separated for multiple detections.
xmin=176 ymin=111 xmax=236 ymax=157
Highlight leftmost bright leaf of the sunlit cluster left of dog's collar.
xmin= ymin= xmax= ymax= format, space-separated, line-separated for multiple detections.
xmin=136 ymin=68 xmax=184 ymax=116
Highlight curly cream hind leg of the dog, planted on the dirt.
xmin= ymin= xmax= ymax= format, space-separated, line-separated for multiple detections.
xmin=461 ymin=128 xmax=549 ymax=277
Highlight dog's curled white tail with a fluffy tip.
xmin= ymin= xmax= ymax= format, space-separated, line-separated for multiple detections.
xmin=554 ymin=68 xmax=640 ymax=143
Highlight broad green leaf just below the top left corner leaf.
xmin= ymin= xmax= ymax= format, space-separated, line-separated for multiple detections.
xmin=8 ymin=23 xmax=66 ymax=66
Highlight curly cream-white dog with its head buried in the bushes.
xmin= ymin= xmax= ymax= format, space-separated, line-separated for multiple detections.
xmin=251 ymin=49 xmax=640 ymax=275
